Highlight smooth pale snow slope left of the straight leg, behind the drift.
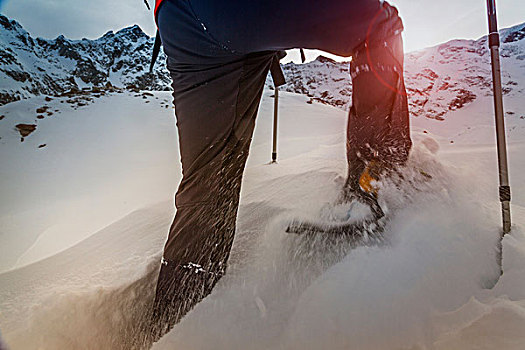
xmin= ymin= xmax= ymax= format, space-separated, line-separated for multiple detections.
xmin=0 ymin=93 xmax=180 ymax=271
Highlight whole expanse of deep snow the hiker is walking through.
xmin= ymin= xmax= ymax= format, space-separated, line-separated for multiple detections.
xmin=0 ymin=91 xmax=525 ymax=350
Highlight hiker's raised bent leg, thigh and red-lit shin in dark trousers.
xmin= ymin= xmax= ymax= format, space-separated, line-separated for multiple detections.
xmin=186 ymin=0 xmax=411 ymax=191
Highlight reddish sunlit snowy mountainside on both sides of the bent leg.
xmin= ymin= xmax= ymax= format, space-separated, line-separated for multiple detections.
xmin=274 ymin=23 xmax=525 ymax=119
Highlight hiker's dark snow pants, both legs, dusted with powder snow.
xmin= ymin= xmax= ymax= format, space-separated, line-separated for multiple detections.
xmin=149 ymin=0 xmax=411 ymax=335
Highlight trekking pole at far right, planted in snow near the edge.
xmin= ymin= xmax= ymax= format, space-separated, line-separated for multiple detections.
xmin=487 ymin=0 xmax=511 ymax=273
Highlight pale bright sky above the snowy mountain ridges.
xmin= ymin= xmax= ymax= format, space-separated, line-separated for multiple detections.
xmin=0 ymin=0 xmax=525 ymax=60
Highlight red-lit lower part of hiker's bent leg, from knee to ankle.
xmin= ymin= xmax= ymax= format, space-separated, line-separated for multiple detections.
xmin=345 ymin=4 xmax=412 ymax=192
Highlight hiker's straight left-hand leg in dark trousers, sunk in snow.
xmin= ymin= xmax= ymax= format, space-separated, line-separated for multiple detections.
xmin=149 ymin=1 xmax=275 ymax=338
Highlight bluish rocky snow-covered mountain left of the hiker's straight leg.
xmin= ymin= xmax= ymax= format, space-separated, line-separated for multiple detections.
xmin=0 ymin=15 xmax=170 ymax=105
